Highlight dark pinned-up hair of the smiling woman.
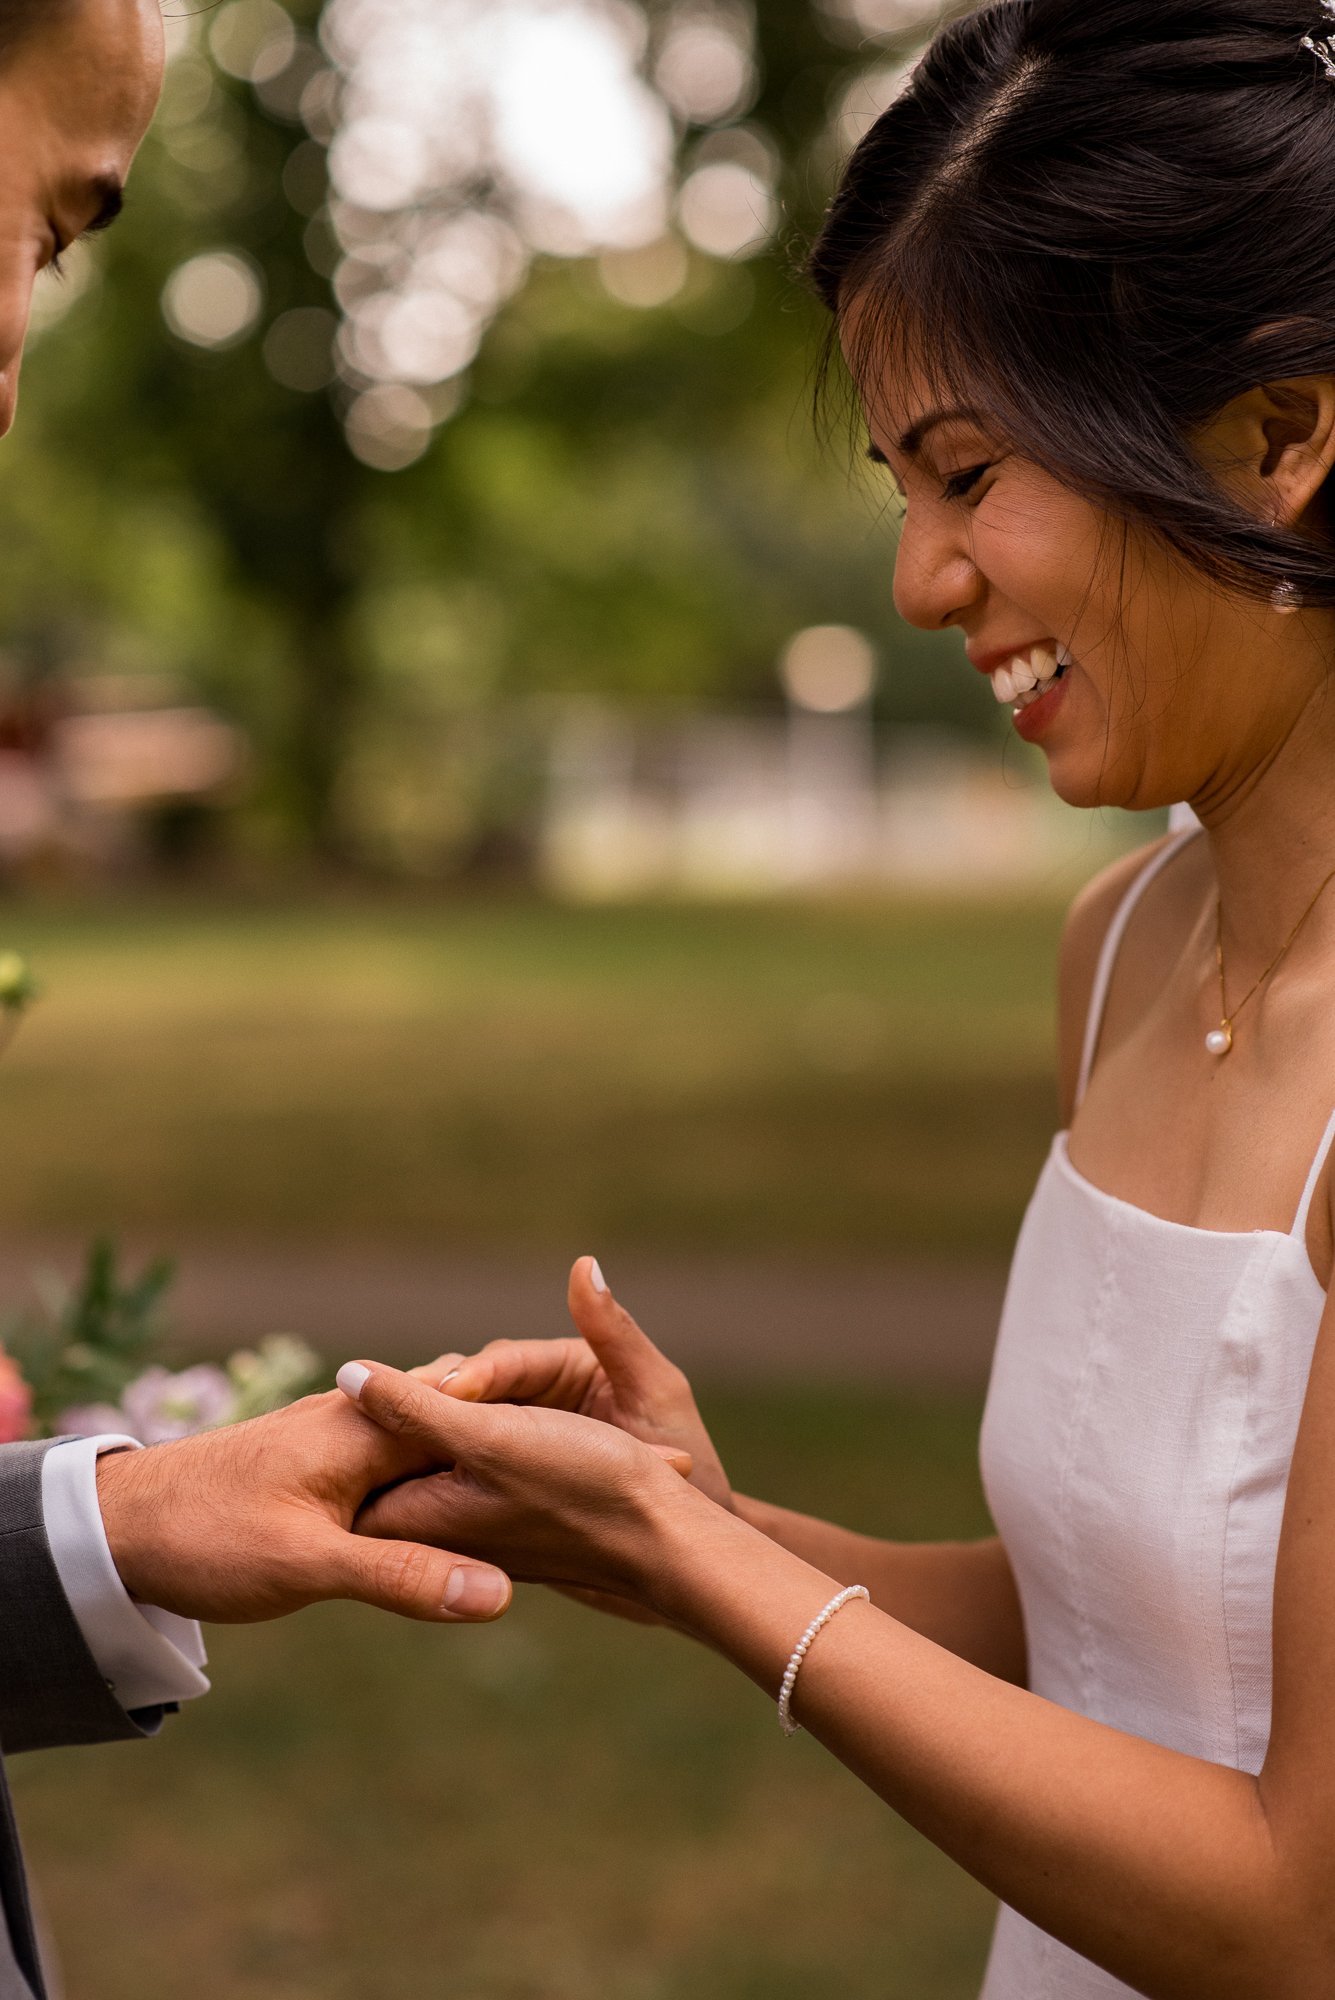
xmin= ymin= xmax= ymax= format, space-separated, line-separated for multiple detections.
xmin=809 ymin=0 xmax=1335 ymax=606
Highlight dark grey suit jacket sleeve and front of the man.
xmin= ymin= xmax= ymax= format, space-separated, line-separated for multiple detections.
xmin=0 ymin=1444 xmax=166 ymax=2000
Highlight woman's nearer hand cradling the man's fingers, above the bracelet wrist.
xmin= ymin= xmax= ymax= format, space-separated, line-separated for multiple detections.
xmin=338 ymin=1362 xmax=703 ymax=1610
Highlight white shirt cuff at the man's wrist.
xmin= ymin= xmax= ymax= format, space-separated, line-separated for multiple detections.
xmin=42 ymin=1434 xmax=208 ymax=1710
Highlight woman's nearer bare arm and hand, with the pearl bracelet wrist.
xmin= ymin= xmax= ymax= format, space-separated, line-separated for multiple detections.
xmin=347 ymin=1312 xmax=1335 ymax=2000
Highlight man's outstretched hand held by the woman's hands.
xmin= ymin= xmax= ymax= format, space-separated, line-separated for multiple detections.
xmin=98 ymin=1392 xmax=510 ymax=1624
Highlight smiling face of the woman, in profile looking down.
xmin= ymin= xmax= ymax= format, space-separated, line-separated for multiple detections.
xmin=849 ymin=354 xmax=1323 ymax=812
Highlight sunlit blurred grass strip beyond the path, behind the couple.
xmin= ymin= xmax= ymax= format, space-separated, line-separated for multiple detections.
xmin=0 ymin=900 xmax=1059 ymax=1254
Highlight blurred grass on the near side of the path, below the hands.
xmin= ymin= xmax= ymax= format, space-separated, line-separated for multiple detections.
xmin=12 ymin=1392 xmax=991 ymax=2000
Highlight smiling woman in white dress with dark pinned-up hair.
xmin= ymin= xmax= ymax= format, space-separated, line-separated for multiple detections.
xmin=340 ymin=0 xmax=1335 ymax=2000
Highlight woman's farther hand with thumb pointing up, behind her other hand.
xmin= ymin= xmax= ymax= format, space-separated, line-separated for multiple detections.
xmin=412 ymin=1256 xmax=733 ymax=1510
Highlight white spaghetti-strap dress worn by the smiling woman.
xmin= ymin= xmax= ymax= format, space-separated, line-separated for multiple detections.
xmin=981 ymin=832 xmax=1335 ymax=2000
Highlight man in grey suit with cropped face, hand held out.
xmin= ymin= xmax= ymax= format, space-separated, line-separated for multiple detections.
xmin=0 ymin=0 xmax=510 ymax=2000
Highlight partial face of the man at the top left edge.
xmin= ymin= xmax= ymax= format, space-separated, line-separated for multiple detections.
xmin=0 ymin=0 xmax=164 ymax=436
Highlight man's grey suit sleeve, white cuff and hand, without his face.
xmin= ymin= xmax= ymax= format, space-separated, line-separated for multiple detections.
xmin=0 ymin=1394 xmax=510 ymax=2000
